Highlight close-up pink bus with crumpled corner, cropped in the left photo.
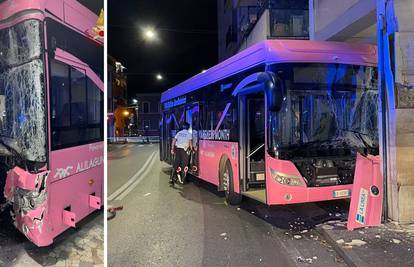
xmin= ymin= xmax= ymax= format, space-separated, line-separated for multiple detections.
xmin=0 ymin=0 xmax=104 ymax=246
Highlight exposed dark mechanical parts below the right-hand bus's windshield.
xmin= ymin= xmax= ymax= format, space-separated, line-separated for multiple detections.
xmin=293 ymin=157 xmax=356 ymax=187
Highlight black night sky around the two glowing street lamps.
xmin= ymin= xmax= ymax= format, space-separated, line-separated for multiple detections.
xmin=108 ymin=0 xmax=218 ymax=97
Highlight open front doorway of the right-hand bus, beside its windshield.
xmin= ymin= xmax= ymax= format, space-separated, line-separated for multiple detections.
xmin=239 ymin=93 xmax=266 ymax=203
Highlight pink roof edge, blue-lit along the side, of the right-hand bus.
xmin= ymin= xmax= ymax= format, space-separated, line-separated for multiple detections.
xmin=161 ymin=40 xmax=377 ymax=102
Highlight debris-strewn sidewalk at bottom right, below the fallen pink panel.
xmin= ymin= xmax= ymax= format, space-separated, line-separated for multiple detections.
xmin=317 ymin=221 xmax=414 ymax=267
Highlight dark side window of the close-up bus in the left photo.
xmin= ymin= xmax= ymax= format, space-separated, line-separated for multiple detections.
xmin=50 ymin=60 xmax=103 ymax=150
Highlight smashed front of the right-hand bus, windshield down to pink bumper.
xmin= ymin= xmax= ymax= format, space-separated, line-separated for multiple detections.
xmin=268 ymin=63 xmax=379 ymax=203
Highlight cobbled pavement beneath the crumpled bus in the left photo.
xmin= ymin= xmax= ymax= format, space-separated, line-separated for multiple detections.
xmin=0 ymin=211 xmax=104 ymax=267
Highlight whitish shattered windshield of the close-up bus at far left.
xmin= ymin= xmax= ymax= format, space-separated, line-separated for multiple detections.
xmin=0 ymin=20 xmax=46 ymax=162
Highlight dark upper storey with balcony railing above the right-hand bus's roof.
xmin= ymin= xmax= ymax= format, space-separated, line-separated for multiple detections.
xmin=217 ymin=0 xmax=309 ymax=61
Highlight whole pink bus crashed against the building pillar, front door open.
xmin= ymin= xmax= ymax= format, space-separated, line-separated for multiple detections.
xmin=160 ymin=40 xmax=379 ymax=209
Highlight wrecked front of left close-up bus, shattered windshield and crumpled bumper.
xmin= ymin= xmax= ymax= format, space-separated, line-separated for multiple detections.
xmin=0 ymin=19 xmax=49 ymax=243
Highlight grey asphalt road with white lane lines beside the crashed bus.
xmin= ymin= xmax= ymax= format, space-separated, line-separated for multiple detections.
xmin=108 ymin=144 xmax=346 ymax=266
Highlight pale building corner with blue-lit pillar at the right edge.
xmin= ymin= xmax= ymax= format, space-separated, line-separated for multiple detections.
xmin=309 ymin=0 xmax=414 ymax=223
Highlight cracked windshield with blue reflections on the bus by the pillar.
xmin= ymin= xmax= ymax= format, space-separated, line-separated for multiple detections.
xmin=269 ymin=64 xmax=378 ymax=158
